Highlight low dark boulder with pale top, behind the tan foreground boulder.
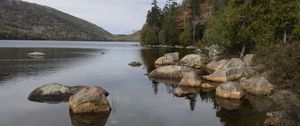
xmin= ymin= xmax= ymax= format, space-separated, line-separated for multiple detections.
xmin=28 ymin=83 xmax=109 ymax=102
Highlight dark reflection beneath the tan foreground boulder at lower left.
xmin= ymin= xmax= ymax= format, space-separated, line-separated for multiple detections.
xmin=69 ymin=110 xmax=110 ymax=126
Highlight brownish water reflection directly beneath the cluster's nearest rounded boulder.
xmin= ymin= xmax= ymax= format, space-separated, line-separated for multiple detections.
xmin=215 ymin=97 xmax=242 ymax=110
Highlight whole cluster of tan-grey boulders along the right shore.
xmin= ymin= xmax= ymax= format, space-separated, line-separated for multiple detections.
xmin=149 ymin=46 xmax=274 ymax=99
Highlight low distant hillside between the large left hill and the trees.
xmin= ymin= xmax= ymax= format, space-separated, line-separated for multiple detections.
xmin=110 ymin=31 xmax=140 ymax=42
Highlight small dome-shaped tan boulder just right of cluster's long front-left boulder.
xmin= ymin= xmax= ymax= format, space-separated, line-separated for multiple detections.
xmin=180 ymin=72 xmax=202 ymax=87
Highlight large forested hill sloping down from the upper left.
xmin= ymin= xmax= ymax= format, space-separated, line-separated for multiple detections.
xmin=0 ymin=0 xmax=113 ymax=40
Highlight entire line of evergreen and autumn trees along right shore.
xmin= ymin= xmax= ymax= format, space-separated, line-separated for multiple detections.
xmin=141 ymin=0 xmax=300 ymax=86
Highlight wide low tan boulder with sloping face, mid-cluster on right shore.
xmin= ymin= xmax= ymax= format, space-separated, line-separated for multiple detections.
xmin=203 ymin=68 xmax=243 ymax=82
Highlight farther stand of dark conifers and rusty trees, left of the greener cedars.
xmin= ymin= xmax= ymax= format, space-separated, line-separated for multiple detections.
xmin=140 ymin=0 xmax=204 ymax=46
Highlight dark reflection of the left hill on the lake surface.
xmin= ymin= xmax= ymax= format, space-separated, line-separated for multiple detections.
xmin=0 ymin=48 xmax=101 ymax=81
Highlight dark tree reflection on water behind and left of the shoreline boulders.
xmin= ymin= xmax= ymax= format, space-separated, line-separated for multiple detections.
xmin=140 ymin=48 xmax=193 ymax=73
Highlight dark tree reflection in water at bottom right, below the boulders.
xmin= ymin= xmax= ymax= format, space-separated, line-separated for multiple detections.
xmin=216 ymin=100 xmax=266 ymax=126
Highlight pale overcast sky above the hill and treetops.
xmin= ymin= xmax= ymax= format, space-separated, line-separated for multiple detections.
xmin=24 ymin=0 xmax=180 ymax=34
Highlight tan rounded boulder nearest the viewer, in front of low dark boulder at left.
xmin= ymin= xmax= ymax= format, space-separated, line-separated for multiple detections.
xmin=69 ymin=87 xmax=111 ymax=113
